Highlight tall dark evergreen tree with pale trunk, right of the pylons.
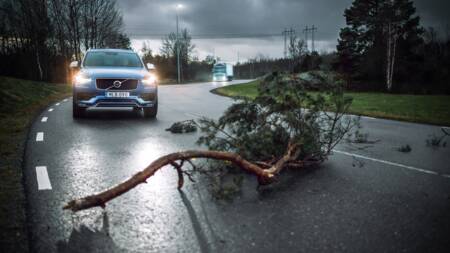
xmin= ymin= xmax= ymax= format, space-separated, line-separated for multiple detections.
xmin=337 ymin=0 xmax=423 ymax=90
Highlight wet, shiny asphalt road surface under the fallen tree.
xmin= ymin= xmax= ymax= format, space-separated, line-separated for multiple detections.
xmin=24 ymin=82 xmax=450 ymax=252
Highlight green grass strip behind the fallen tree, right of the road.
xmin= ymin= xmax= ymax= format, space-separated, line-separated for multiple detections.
xmin=212 ymin=81 xmax=450 ymax=126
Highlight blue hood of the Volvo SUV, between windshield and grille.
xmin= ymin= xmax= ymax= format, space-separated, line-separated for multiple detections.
xmin=81 ymin=68 xmax=148 ymax=79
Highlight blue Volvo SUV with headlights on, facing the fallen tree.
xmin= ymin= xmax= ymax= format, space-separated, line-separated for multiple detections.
xmin=70 ymin=49 xmax=158 ymax=118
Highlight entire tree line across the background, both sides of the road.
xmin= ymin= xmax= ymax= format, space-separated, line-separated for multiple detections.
xmin=0 ymin=0 xmax=450 ymax=94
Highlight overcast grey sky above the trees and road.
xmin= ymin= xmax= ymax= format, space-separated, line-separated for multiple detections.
xmin=117 ymin=0 xmax=450 ymax=62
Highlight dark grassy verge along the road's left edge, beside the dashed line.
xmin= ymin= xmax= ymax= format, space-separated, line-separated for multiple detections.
xmin=0 ymin=77 xmax=71 ymax=252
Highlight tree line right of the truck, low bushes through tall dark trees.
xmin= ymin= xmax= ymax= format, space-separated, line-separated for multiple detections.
xmin=235 ymin=0 xmax=450 ymax=94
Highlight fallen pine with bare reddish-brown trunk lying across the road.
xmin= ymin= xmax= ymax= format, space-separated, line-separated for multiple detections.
xmin=64 ymin=73 xmax=356 ymax=212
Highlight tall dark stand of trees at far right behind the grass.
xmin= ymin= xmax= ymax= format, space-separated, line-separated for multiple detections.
xmin=336 ymin=0 xmax=450 ymax=93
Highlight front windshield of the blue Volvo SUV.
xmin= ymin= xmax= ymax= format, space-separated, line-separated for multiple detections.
xmin=84 ymin=52 xmax=142 ymax=68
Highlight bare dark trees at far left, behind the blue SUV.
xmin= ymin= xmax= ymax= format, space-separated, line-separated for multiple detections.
xmin=0 ymin=0 xmax=130 ymax=82
